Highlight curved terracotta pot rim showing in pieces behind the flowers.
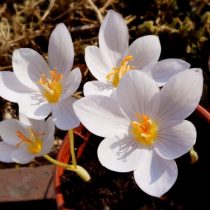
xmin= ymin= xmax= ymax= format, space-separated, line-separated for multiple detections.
xmin=54 ymin=105 xmax=210 ymax=210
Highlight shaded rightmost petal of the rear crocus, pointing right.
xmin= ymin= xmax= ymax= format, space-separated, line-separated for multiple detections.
xmin=151 ymin=58 xmax=190 ymax=86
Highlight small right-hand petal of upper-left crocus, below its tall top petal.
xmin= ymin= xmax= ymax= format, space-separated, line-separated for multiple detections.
xmin=61 ymin=68 xmax=82 ymax=100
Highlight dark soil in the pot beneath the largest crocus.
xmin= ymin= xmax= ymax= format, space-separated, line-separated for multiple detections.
xmin=61 ymin=113 xmax=210 ymax=210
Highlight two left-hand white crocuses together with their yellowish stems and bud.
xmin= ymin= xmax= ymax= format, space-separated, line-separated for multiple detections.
xmin=0 ymin=23 xmax=90 ymax=181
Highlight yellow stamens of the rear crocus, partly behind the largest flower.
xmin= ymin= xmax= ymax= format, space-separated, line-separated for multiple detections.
xmin=106 ymin=55 xmax=135 ymax=87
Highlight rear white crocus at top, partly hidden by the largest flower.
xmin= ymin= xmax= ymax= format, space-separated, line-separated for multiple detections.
xmin=84 ymin=10 xmax=190 ymax=96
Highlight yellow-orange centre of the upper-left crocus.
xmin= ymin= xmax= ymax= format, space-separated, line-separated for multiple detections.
xmin=38 ymin=68 xmax=63 ymax=103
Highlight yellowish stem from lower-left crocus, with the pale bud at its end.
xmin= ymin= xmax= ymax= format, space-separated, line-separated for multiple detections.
xmin=43 ymin=155 xmax=90 ymax=182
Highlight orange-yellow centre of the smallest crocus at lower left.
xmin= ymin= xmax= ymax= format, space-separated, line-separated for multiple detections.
xmin=16 ymin=128 xmax=45 ymax=155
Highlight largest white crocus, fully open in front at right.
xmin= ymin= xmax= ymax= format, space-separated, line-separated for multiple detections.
xmin=74 ymin=69 xmax=203 ymax=197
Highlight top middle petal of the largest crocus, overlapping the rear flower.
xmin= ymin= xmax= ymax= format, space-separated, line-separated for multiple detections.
xmin=116 ymin=70 xmax=159 ymax=119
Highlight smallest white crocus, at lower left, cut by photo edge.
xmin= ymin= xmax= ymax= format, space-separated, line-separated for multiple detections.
xmin=0 ymin=114 xmax=55 ymax=164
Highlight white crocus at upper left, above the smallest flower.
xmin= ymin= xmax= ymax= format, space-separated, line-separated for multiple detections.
xmin=0 ymin=24 xmax=81 ymax=130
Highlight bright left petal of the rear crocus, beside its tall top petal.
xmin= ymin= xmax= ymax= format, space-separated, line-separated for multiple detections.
xmin=85 ymin=46 xmax=111 ymax=82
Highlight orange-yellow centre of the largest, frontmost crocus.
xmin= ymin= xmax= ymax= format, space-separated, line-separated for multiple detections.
xmin=131 ymin=113 xmax=158 ymax=146
